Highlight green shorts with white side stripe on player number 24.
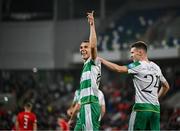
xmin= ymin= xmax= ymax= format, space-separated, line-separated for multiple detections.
xmin=128 ymin=111 xmax=160 ymax=131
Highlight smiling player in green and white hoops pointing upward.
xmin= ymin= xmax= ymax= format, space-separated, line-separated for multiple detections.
xmin=69 ymin=11 xmax=101 ymax=130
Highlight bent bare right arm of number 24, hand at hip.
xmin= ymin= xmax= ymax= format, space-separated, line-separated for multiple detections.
xmin=158 ymin=81 xmax=170 ymax=98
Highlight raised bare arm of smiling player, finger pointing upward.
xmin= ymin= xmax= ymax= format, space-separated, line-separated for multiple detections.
xmin=87 ymin=11 xmax=97 ymax=60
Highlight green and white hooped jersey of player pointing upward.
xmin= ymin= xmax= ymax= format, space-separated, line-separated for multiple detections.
xmin=80 ymin=58 xmax=101 ymax=105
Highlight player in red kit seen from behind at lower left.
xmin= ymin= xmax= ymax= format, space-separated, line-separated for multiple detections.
xmin=16 ymin=103 xmax=37 ymax=131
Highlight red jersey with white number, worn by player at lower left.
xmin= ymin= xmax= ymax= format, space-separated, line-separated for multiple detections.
xmin=17 ymin=112 xmax=37 ymax=131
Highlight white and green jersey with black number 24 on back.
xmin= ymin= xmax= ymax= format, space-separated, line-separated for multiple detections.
xmin=127 ymin=61 xmax=166 ymax=111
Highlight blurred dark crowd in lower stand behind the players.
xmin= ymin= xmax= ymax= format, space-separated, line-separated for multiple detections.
xmin=0 ymin=63 xmax=180 ymax=130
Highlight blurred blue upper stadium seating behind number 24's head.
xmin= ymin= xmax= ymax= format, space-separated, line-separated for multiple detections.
xmin=98 ymin=7 xmax=180 ymax=51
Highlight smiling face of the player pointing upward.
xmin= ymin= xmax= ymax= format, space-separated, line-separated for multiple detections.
xmin=80 ymin=42 xmax=90 ymax=60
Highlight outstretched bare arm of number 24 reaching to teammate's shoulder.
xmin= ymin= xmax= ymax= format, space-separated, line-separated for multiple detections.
xmin=99 ymin=57 xmax=128 ymax=73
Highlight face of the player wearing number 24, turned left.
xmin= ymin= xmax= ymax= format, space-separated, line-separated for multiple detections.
xmin=130 ymin=47 xmax=141 ymax=62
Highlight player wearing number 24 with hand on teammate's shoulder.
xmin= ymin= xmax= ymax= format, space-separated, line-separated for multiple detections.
xmin=99 ymin=41 xmax=169 ymax=130
